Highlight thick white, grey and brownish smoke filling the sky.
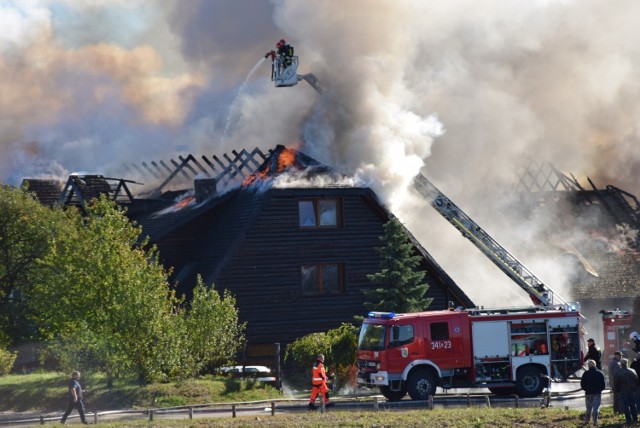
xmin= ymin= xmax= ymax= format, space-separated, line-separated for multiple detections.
xmin=0 ymin=0 xmax=640 ymax=305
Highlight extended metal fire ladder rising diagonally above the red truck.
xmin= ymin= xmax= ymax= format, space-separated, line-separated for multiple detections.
xmin=414 ymin=174 xmax=575 ymax=310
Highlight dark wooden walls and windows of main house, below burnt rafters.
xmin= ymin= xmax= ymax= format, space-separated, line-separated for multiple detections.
xmin=129 ymin=187 xmax=474 ymax=343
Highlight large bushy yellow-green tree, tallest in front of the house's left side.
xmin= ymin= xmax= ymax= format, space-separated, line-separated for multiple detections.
xmin=29 ymin=197 xmax=180 ymax=381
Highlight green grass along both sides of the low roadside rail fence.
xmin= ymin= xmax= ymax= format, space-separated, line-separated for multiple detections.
xmin=0 ymin=373 xmax=640 ymax=428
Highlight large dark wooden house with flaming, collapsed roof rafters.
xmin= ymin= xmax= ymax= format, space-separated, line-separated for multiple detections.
xmin=22 ymin=146 xmax=474 ymax=344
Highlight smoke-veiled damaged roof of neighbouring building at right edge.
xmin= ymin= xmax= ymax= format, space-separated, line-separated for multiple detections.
xmin=517 ymin=164 xmax=640 ymax=309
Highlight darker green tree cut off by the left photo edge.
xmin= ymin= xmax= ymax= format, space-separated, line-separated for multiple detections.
xmin=0 ymin=185 xmax=64 ymax=347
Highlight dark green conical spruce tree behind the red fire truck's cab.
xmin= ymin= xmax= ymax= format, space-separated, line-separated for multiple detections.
xmin=364 ymin=219 xmax=433 ymax=313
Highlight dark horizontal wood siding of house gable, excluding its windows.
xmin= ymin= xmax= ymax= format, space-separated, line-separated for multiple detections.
xmin=215 ymin=189 xmax=464 ymax=343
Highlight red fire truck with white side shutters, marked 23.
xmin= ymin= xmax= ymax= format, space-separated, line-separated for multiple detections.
xmin=358 ymin=307 xmax=583 ymax=401
